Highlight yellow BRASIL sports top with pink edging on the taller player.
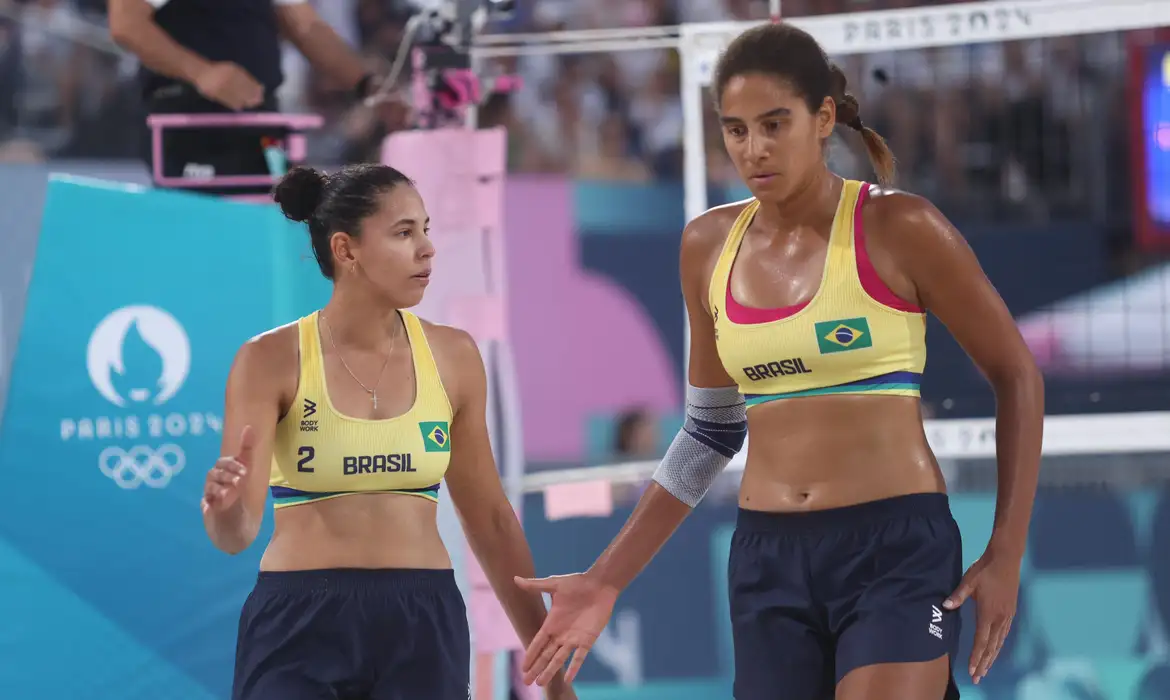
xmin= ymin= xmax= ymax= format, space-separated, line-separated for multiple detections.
xmin=709 ymin=180 xmax=927 ymax=407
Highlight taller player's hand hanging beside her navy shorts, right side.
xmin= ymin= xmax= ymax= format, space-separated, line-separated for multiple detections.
xmin=943 ymin=550 xmax=1020 ymax=684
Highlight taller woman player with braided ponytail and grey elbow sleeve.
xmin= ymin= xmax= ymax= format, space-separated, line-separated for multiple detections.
xmin=514 ymin=25 xmax=1044 ymax=700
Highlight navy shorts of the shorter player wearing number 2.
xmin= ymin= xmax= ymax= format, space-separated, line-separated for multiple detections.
xmin=232 ymin=569 xmax=472 ymax=700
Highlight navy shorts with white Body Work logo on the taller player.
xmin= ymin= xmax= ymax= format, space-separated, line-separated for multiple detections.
xmin=728 ymin=494 xmax=963 ymax=700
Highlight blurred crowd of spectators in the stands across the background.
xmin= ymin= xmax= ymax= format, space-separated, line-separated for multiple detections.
xmin=0 ymin=0 xmax=1151 ymax=220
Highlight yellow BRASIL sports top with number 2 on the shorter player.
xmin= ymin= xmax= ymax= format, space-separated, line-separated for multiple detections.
xmin=268 ymin=311 xmax=452 ymax=508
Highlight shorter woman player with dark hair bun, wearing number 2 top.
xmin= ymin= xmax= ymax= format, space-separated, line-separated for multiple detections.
xmin=202 ymin=165 xmax=573 ymax=700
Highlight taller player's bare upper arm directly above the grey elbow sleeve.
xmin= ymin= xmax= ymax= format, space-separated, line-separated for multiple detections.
xmin=679 ymin=224 xmax=735 ymax=387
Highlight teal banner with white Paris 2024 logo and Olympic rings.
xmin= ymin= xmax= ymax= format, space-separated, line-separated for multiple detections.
xmin=0 ymin=179 xmax=329 ymax=700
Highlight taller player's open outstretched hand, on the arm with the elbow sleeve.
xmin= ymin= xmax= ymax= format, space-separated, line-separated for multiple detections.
xmin=516 ymin=574 xmax=618 ymax=686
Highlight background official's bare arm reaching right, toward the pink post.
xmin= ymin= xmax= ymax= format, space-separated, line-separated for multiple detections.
xmin=271 ymin=0 xmax=372 ymax=96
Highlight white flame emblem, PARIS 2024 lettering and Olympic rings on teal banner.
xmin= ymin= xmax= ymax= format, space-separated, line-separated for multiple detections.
xmin=60 ymin=306 xmax=222 ymax=489
